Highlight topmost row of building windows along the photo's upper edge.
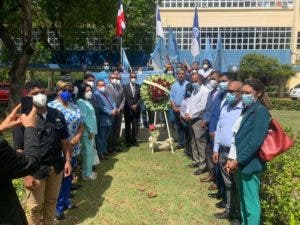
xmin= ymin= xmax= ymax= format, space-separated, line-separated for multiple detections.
xmin=161 ymin=0 xmax=294 ymax=8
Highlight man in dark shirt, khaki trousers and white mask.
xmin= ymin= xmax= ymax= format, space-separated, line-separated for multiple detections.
xmin=13 ymin=80 xmax=72 ymax=225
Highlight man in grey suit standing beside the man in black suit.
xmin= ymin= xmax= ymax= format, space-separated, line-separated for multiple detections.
xmin=106 ymin=70 xmax=125 ymax=152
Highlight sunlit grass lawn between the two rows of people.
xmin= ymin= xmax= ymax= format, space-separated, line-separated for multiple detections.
xmin=59 ymin=143 xmax=229 ymax=225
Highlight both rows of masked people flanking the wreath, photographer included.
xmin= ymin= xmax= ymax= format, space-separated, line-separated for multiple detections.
xmin=0 ymin=60 xmax=270 ymax=225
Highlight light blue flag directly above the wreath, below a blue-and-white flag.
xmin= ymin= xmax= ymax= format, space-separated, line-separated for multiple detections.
xmin=150 ymin=37 xmax=167 ymax=70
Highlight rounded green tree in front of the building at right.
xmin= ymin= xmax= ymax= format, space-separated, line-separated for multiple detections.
xmin=239 ymin=53 xmax=295 ymax=97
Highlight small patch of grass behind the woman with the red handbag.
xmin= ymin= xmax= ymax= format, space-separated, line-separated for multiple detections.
xmin=271 ymin=110 xmax=300 ymax=132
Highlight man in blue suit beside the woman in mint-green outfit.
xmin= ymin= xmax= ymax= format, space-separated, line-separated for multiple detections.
xmin=95 ymin=80 xmax=118 ymax=160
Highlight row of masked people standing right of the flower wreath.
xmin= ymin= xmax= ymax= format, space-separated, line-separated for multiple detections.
xmin=167 ymin=60 xmax=270 ymax=225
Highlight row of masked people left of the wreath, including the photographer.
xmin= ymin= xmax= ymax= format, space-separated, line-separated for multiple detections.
xmin=0 ymin=66 xmax=141 ymax=225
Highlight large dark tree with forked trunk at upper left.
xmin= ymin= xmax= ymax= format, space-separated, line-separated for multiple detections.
xmin=0 ymin=0 xmax=33 ymax=106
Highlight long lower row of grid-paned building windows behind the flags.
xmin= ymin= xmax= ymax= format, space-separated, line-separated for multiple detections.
xmin=165 ymin=27 xmax=292 ymax=50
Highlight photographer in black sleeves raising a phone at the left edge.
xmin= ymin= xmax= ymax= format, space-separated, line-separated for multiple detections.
xmin=0 ymin=105 xmax=40 ymax=225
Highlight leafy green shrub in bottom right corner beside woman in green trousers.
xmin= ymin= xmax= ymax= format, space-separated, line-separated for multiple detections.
xmin=261 ymin=130 xmax=300 ymax=225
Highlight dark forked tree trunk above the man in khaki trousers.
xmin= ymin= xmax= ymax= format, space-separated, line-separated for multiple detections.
xmin=0 ymin=0 xmax=33 ymax=107
